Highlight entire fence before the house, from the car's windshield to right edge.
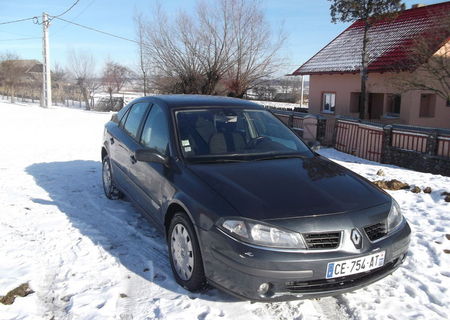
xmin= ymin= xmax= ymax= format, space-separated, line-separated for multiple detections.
xmin=271 ymin=109 xmax=450 ymax=175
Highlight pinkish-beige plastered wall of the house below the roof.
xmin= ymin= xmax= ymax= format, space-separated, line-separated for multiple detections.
xmin=309 ymin=73 xmax=450 ymax=128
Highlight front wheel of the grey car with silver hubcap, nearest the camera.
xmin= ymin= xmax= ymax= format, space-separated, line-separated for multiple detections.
xmin=167 ymin=212 xmax=206 ymax=292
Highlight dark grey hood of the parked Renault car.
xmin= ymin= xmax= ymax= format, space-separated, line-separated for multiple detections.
xmin=189 ymin=157 xmax=390 ymax=220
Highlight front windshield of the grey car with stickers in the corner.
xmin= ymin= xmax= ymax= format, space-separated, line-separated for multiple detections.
xmin=175 ymin=107 xmax=313 ymax=162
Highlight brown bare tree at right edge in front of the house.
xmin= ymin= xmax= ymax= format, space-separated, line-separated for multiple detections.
xmin=392 ymin=13 xmax=450 ymax=106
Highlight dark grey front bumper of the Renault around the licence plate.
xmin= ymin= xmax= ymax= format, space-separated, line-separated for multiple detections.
xmin=200 ymin=220 xmax=411 ymax=301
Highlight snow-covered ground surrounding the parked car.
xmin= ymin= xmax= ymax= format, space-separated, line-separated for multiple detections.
xmin=0 ymin=102 xmax=450 ymax=320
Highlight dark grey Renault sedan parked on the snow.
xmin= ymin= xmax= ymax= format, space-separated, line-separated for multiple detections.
xmin=101 ymin=95 xmax=411 ymax=301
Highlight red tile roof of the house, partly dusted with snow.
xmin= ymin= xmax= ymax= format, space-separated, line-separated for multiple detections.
xmin=293 ymin=1 xmax=450 ymax=75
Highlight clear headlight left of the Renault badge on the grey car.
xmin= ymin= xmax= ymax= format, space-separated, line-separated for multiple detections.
xmin=219 ymin=218 xmax=306 ymax=249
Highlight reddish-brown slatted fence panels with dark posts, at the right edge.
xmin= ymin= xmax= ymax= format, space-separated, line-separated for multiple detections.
xmin=334 ymin=117 xmax=450 ymax=176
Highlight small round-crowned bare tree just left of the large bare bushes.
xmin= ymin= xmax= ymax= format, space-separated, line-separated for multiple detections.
xmin=102 ymin=61 xmax=131 ymax=108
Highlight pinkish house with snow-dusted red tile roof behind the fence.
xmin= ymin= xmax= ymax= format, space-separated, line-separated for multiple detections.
xmin=293 ymin=1 xmax=450 ymax=128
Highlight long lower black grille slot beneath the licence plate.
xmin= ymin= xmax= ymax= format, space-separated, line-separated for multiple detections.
xmin=285 ymin=258 xmax=399 ymax=293
